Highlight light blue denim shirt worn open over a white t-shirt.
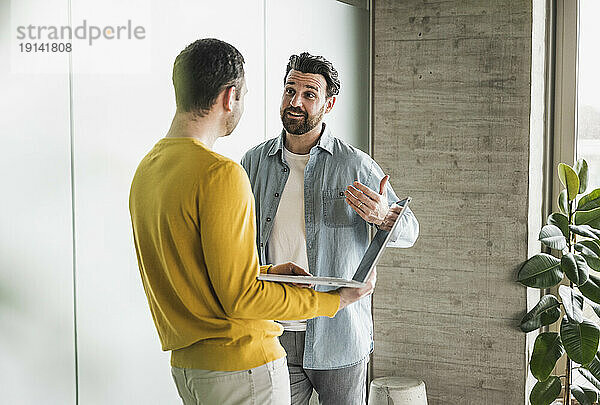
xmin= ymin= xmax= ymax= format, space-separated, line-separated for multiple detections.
xmin=242 ymin=127 xmax=419 ymax=370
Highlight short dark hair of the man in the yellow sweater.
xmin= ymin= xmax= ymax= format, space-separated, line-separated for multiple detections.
xmin=173 ymin=38 xmax=244 ymax=116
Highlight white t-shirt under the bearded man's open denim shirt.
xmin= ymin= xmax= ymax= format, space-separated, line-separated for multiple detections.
xmin=267 ymin=147 xmax=310 ymax=331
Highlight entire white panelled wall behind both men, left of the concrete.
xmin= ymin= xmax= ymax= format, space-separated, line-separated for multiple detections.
xmin=0 ymin=0 xmax=369 ymax=405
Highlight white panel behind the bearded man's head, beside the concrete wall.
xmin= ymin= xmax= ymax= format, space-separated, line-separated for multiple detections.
xmin=265 ymin=0 xmax=370 ymax=152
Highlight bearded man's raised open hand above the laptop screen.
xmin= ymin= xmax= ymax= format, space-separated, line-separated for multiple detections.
xmin=345 ymin=174 xmax=397 ymax=226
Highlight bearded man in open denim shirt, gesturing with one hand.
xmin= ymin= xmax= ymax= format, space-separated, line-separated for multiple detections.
xmin=242 ymin=52 xmax=419 ymax=405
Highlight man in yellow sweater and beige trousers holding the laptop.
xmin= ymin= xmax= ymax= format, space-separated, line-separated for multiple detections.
xmin=129 ymin=39 xmax=375 ymax=405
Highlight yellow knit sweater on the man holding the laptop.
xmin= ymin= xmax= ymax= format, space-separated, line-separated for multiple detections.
xmin=129 ymin=138 xmax=340 ymax=371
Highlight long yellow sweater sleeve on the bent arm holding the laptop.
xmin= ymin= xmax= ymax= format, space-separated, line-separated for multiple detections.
xmin=198 ymin=161 xmax=340 ymax=320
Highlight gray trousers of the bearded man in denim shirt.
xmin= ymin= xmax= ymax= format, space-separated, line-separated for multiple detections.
xmin=279 ymin=331 xmax=368 ymax=405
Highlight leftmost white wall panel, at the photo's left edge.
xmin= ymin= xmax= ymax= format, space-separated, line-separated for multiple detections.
xmin=0 ymin=0 xmax=75 ymax=405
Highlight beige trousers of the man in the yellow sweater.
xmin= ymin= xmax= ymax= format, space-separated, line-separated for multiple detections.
xmin=171 ymin=357 xmax=291 ymax=405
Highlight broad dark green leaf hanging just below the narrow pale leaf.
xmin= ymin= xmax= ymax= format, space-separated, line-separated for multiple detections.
xmin=560 ymin=316 xmax=600 ymax=365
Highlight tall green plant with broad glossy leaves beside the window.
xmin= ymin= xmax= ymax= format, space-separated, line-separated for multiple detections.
xmin=517 ymin=159 xmax=600 ymax=405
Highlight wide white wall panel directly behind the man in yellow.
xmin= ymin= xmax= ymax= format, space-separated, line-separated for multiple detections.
xmin=73 ymin=0 xmax=264 ymax=405
